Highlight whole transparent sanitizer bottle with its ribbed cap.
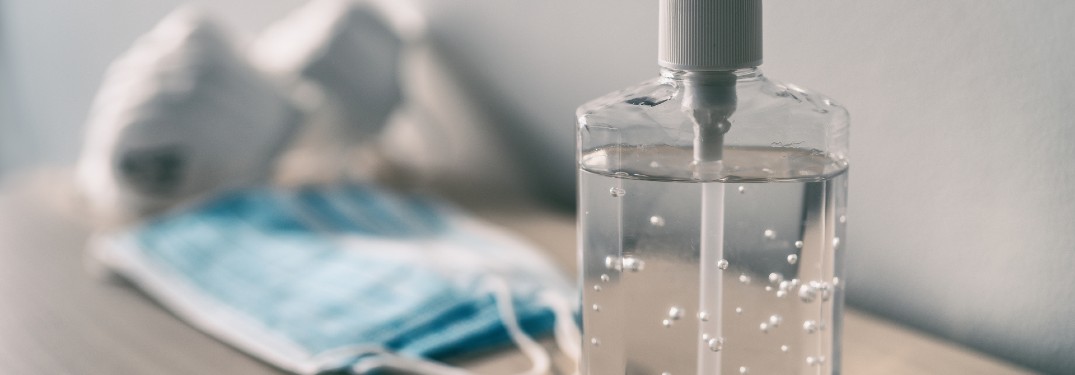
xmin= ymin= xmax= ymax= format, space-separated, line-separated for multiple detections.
xmin=577 ymin=0 xmax=848 ymax=375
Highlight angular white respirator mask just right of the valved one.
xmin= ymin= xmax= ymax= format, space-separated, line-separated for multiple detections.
xmin=250 ymin=0 xmax=425 ymax=141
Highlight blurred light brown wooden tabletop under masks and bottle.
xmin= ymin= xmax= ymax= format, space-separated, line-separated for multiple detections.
xmin=0 ymin=173 xmax=1031 ymax=375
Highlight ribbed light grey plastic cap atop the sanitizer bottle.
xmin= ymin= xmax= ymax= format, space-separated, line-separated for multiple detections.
xmin=658 ymin=0 xmax=761 ymax=71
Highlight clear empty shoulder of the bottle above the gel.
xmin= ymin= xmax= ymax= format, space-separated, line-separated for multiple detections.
xmin=576 ymin=74 xmax=850 ymax=178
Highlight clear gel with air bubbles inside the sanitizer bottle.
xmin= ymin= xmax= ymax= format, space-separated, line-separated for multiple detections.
xmin=579 ymin=146 xmax=846 ymax=375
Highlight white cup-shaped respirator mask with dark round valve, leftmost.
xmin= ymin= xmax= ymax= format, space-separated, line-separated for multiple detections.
xmin=78 ymin=8 xmax=300 ymax=222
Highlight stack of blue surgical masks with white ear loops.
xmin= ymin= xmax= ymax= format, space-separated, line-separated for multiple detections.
xmin=96 ymin=182 xmax=578 ymax=374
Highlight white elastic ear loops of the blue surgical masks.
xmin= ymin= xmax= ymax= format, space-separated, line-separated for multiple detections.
xmin=350 ymin=278 xmax=554 ymax=375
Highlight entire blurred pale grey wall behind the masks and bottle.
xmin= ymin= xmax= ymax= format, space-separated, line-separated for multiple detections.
xmin=0 ymin=0 xmax=1075 ymax=374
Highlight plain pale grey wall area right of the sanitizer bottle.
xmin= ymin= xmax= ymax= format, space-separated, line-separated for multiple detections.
xmin=768 ymin=0 xmax=1075 ymax=373
